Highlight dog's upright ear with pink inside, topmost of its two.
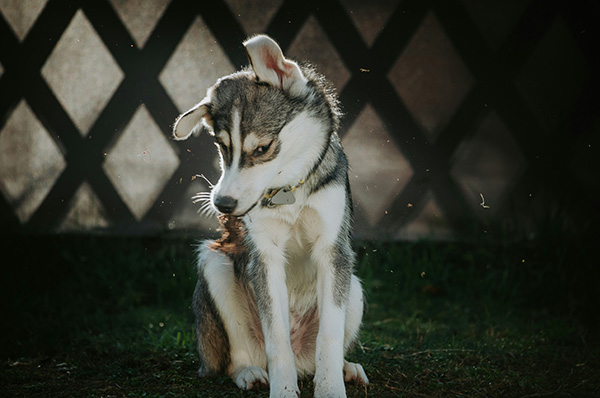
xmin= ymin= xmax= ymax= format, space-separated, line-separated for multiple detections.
xmin=244 ymin=35 xmax=307 ymax=93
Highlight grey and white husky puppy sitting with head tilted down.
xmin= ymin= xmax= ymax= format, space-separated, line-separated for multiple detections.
xmin=173 ymin=35 xmax=369 ymax=398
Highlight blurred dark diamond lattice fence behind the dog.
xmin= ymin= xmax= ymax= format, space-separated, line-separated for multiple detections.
xmin=0 ymin=0 xmax=600 ymax=240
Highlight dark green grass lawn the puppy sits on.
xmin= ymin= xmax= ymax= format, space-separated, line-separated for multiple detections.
xmin=0 ymin=236 xmax=600 ymax=397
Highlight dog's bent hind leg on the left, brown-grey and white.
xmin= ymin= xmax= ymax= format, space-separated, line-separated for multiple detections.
xmin=194 ymin=244 xmax=268 ymax=390
